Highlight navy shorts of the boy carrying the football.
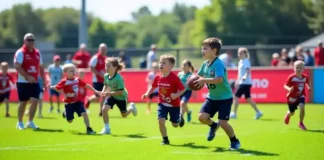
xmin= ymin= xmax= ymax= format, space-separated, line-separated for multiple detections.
xmin=200 ymin=98 xmax=233 ymax=120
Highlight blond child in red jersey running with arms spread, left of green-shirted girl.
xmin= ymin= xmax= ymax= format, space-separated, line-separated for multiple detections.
xmin=50 ymin=64 xmax=100 ymax=134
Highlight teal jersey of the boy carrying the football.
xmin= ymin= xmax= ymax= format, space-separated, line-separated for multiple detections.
xmin=198 ymin=57 xmax=233 ymax=100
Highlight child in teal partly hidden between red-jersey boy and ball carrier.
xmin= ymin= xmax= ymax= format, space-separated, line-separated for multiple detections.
xmin=178 ymin=60 xmax=196 ymax=123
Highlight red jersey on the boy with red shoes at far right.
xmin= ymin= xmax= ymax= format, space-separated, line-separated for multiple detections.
xmin=285 ymin=73 xmax=309 ymax=103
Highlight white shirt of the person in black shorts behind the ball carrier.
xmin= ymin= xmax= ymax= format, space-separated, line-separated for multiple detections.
xmin=238 ymin=58 xmax=252 ymax=84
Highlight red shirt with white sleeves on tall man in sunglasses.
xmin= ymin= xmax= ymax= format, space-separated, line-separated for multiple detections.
xmin=14 ymin=45 xmax=43 ymax=83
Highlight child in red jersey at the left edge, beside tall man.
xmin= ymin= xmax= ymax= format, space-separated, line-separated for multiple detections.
xmin=0 ymin=62 xmax=14 ymax=117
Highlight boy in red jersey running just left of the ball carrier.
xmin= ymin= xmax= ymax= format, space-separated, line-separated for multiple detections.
xmin=142 ymin=54 xmax=186 ymax=145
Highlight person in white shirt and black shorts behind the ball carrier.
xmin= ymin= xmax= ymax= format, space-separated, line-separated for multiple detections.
xmin=230 ymin=48 xmax=263 ymax=119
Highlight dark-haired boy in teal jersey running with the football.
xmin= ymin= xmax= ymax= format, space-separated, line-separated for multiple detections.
xmin=195 ymin=38 xmax=241 ymax=150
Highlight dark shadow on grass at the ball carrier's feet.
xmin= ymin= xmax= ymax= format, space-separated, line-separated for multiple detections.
xmin=214 ymin=147 xmax=279 ymax=156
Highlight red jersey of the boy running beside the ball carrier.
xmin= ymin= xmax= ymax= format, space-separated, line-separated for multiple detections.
xmin=152 ymin=72 xmax=185 ymax=107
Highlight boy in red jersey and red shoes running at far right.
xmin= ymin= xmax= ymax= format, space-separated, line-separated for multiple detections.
xmin=284 ymin=60 xmax=311 ymax=130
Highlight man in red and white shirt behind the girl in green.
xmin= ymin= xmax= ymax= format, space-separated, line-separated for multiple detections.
xmin=85 ymin=43 xmax=107 ymax=116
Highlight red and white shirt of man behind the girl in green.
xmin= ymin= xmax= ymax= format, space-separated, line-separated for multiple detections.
xmin=90 ymin=53 xmax=107 ymax=83
